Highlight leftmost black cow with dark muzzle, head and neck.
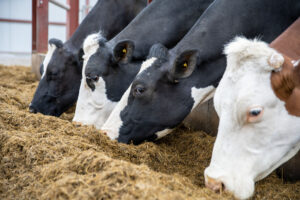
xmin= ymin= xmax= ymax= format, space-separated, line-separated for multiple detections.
xmin=29 ymin=0 xmax=147 ymax=116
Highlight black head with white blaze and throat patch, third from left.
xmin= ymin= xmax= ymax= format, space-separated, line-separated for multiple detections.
xmin=101 ymin=44 xmax=224 ymax=144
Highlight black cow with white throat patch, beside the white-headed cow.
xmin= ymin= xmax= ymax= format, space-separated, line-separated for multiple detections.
xmin=101 ymin=0 xmax=300 ymax=144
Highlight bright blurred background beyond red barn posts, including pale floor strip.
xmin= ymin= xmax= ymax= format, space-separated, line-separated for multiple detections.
xmin=0 ymin=0 xmax=97 ymax=66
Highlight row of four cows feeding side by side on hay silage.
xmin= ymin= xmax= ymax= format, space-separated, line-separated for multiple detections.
xmin=29 ymin=0 xmax=300 ymax=199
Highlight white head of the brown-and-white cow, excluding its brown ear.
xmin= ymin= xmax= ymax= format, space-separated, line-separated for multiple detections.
xmin=205 ymin=38 xmax=300 ymax=199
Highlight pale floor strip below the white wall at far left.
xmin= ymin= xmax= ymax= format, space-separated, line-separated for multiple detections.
xmin=0 ymin=52 xmax=31 ymax=67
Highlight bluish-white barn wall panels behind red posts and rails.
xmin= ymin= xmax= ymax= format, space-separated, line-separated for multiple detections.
xmin=0 ymin=0 xmax=97 ymax=54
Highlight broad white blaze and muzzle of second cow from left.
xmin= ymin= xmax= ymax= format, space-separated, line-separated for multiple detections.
xmin=73 ymin=34 xmax=116 ymax=129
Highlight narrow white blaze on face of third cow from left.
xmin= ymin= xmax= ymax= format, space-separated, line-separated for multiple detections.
xmin=101 ymin=57 xmax=157 ymax=140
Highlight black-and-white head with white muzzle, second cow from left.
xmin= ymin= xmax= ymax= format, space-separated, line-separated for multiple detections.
xmin=73 ymin=33 xmax=140 ymax=128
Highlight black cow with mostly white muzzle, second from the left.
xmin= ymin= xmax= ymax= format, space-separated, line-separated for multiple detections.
xmin=73 ymin=0 xmax=212 ymax=129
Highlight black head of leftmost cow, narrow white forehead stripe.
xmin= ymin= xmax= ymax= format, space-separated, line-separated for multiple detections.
xmin=29 ymin=39 xmax=83 ymax=116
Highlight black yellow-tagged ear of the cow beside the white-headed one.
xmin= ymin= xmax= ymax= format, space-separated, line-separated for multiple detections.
xmin=170 ymin=50 xmax=198 ymax=80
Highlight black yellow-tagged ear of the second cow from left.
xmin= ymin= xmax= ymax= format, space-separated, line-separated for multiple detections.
xmin=113 ymin=40 xmax=134 ymax=64
